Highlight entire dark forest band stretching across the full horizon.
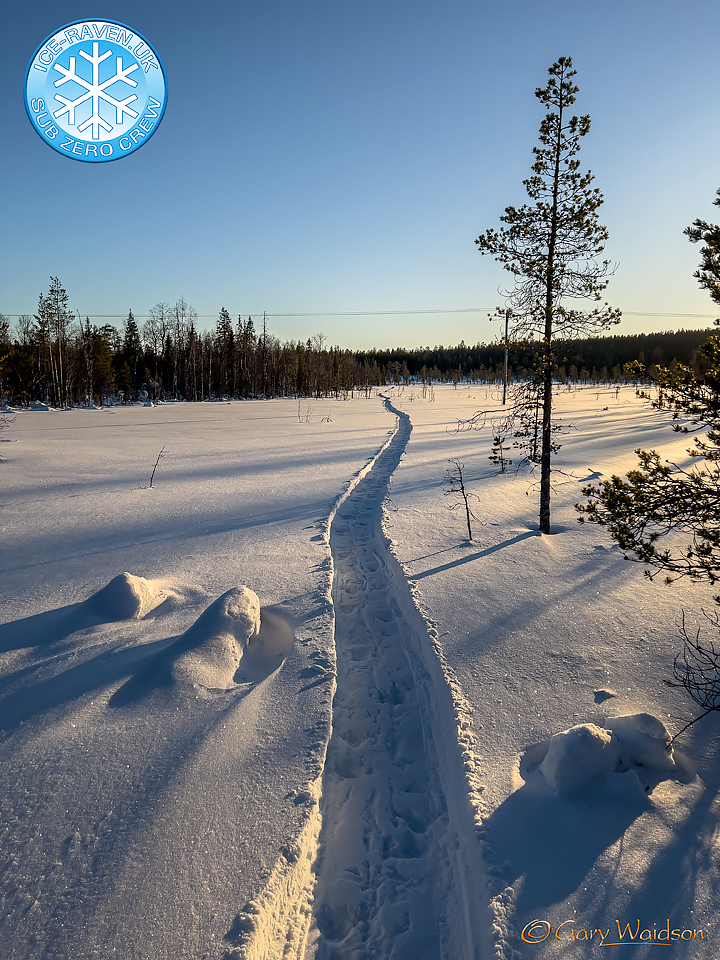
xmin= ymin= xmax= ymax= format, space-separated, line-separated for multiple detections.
xmin=0 ymin=278 xmax=713 ymax=406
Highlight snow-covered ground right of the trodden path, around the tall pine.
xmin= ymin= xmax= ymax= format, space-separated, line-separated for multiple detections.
xmin=387 ymin=386 xmax=720 ymax=960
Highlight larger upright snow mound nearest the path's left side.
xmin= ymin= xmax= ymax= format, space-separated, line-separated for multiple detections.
xmin=172 ymin=586 xmax=260 ymax=690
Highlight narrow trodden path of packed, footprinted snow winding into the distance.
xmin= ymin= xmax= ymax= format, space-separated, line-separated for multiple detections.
xmin=306 ymin=404 xmax=486 ymax=960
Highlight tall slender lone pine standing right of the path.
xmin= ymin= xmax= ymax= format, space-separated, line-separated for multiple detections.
xmin=475 ymin=57 xmax=620 ymax=533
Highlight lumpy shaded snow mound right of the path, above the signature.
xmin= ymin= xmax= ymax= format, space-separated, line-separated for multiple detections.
xmin=540 ymin=713 xmax=675 ymax=796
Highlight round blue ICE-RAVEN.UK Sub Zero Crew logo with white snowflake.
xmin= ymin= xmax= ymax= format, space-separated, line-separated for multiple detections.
xmin=25 ymin=20 xmax=167 ymax=163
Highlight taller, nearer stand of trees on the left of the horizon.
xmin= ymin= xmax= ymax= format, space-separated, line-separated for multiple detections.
xmin=0 ymin=277 xmax=385 ymax=407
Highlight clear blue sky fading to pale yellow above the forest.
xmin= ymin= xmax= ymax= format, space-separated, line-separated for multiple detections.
xmin=0 ymin=0 xmax=720 ymax=348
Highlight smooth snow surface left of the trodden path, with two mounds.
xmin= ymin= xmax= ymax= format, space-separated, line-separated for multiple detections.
xmin=0 ymin=398 xmax=394 ymax=960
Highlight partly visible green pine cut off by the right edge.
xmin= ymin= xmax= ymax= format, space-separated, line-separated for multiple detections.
xmin=576 ymin=191 xmax=720 ymax=736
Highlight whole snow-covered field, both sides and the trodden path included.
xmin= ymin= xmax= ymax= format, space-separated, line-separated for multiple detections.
xmin=0 ymin=385 xmax=720 ymax=960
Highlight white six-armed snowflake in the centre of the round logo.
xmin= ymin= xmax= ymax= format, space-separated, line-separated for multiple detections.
xmin=53 ymin=42 xmax=139 ymax=140
